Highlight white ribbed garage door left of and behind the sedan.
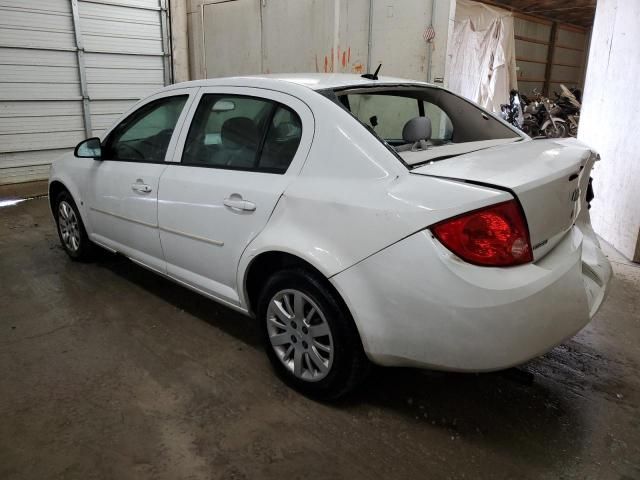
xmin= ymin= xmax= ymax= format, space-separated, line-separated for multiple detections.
xmin=0 ymin=0 xmax=171 ymax=185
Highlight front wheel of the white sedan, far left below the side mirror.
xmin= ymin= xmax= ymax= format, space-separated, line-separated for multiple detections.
xmin=55 ymin=191 xmax=94 ymax=261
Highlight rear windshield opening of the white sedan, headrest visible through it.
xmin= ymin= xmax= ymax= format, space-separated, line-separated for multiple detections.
xmin=322 ymin=86 xmax=523 ymax=166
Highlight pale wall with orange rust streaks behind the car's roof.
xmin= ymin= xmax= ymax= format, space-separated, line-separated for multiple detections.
xmin=187 ymin=0 xmax=455 ymax=87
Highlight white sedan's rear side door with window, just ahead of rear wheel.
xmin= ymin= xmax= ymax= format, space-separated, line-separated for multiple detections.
xmin=158 ymin=87 xmax=314 ymax=305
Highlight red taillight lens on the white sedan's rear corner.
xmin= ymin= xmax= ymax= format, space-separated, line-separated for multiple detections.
xmin=431 ymin=200 xmax=533 ymax=267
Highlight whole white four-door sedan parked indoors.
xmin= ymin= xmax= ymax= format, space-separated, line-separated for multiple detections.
xmin=49 ymin=74 xmax=611 ymax=398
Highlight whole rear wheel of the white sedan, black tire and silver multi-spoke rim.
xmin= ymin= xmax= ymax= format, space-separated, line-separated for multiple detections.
xmin=258 ymin=269 xmax=368 ymax=400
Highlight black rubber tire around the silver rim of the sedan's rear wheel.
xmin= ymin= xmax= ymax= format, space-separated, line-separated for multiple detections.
xmin=257 ymin=268 xmax=370 ymax=400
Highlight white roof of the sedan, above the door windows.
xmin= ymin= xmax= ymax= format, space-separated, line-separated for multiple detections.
xmin=167 ymin=73 xmax=435 ymax=90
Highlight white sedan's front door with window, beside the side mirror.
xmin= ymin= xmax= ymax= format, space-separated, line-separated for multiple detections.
xmin=87 ymin=89 xmax=191 ymax=273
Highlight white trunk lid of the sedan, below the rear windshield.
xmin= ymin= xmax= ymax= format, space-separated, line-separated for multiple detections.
xmin=411 ymin=139 xmax=595 ymax=260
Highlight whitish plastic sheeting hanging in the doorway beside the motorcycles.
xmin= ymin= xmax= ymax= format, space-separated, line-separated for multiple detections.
xmin=447 ymin=0 xmax=518 ymax=112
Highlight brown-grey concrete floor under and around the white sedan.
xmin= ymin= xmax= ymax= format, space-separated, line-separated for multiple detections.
xmin=0 ymin=198 xmax=640 ymax=480
